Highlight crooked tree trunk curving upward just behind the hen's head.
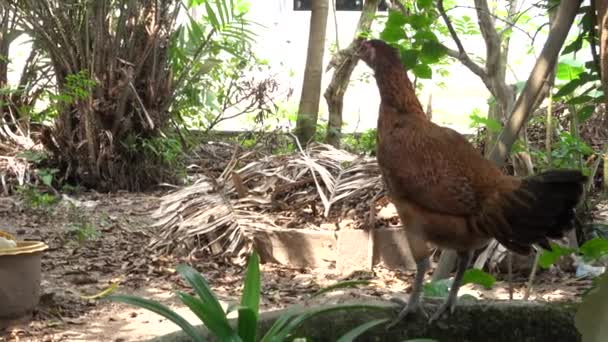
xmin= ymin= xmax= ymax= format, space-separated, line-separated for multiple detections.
xmin=324 ymin=0 xmax=380 ymax=147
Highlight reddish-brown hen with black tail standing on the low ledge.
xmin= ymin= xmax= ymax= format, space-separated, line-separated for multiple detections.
xmin=358 ymin=39 xmax=586 ymax=324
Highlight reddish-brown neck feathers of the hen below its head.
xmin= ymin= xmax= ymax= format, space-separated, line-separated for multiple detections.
xmin=375 ymin=62 xmax=426 ymax=117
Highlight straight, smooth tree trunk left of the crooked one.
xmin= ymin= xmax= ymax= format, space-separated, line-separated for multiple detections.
xmin=296 ymin=0 xmax=329 ymax=144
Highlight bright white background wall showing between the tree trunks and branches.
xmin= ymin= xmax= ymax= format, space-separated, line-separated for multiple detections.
xmin=238 ymin=0 xmax=564 ymax=131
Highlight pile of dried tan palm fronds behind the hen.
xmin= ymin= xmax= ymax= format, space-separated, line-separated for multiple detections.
xmin=151 ymin=144 xmax=384 ymax=256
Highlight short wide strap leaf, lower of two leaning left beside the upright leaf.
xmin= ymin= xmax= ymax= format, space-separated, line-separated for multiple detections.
xmin=177 ymin=292 xmax=240 ymax=341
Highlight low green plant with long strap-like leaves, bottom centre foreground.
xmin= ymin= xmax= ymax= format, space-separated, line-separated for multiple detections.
xmin=107 ymin=252 xmax=388 ymax=342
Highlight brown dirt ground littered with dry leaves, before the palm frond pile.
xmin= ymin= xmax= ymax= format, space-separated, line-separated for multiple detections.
xmin=0 ymin=193 xmax=590 ymax=341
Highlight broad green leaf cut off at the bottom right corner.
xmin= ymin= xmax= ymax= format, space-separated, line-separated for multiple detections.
xmin=574 ymin=273 xmax=608 ymax=341
